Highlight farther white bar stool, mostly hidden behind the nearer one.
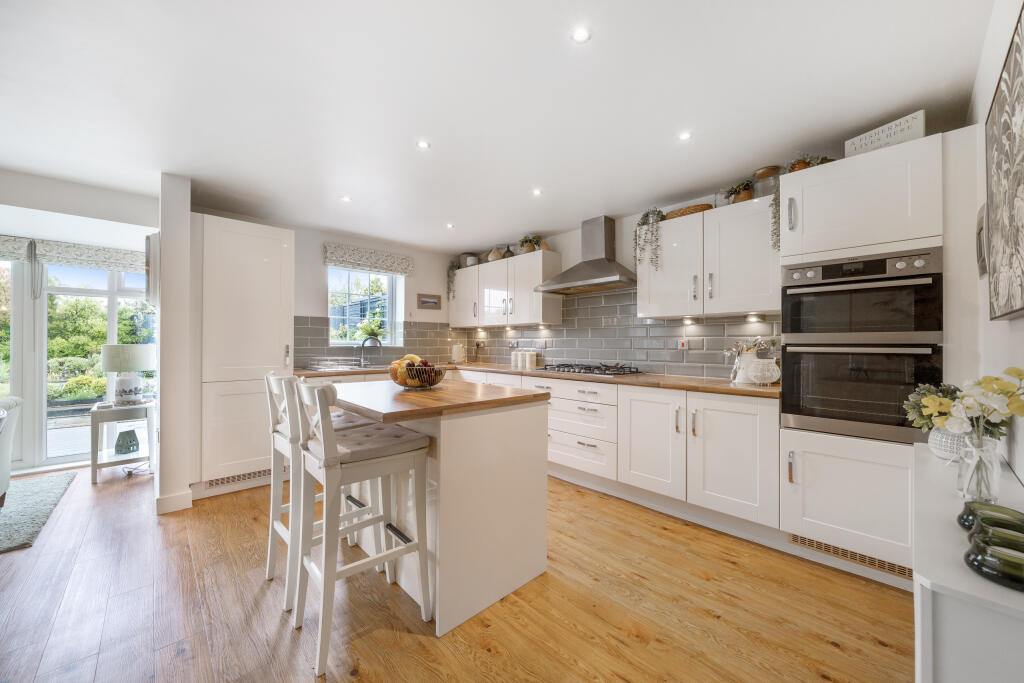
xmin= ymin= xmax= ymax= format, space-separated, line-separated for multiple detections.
xmin=265 ymin=373 xmax=374 ymax=611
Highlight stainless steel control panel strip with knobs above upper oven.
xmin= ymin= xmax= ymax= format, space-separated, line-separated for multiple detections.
xmin=782 ymin=249 xmax=942 ymax=287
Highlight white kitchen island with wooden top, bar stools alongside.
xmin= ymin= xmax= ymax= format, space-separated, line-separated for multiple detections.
xmin=335 ymin=379 xmax=550 ymax=636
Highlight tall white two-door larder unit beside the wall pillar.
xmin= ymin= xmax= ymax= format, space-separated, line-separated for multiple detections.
xmin=202 ymin=216 xmax=295 ymax=481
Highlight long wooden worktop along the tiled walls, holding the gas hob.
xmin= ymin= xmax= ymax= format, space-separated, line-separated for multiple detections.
xmin=295 ymin=362 xmax=780 ymax=398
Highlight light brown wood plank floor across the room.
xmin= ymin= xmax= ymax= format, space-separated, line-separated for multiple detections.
xmin=0 ymin=469 xmax=913 ymax=681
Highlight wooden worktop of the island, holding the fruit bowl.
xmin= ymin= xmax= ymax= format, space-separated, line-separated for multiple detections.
xmin=335 ymin=373 xmax=551 ymax=423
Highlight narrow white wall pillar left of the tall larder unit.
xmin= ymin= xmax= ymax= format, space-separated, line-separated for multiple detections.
xmin=154 ymin=173 xmax=200 ymax=514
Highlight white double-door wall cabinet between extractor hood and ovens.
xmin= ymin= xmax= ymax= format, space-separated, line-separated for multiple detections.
xmin=637 ymin=198 xmax=781 ymax=317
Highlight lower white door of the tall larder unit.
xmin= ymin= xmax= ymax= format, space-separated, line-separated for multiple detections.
xmin=202 ymin=379 xmax=270 ymax=481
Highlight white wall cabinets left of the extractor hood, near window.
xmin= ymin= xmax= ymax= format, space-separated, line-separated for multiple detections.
xmin=449 ymin=251 xmax=562 ymax=328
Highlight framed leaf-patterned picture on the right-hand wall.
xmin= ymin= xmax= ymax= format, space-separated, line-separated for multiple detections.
xmin=985 ymin=3 xmax=1024 ymax=321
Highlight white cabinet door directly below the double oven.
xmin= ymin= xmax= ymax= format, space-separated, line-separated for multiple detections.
xmin=779 ymin=429 xmax=917 ymax=566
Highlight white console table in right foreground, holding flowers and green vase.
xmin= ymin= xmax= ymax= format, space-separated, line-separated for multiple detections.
xmin=913 ymin=443 xmax=1024 ymax=683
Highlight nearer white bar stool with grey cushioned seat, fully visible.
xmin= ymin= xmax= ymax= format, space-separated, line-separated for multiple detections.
xmin=292 ymin=384 xmax=433 ymax=676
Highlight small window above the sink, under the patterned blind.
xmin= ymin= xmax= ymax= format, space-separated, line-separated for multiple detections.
xmin=327 ymin=267 xmax=403 ymax=346
